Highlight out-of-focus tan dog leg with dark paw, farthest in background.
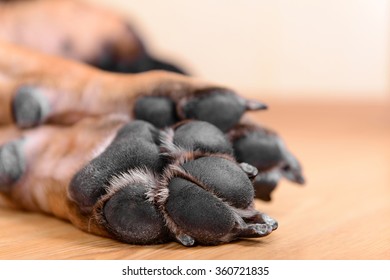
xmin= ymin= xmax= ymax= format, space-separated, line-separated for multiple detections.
xmin=0 ymin=0 xmax=183 ymax=73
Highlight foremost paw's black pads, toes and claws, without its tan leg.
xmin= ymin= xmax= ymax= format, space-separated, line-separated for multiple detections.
xmin=74 ymin=121 xmax=276 ymax=246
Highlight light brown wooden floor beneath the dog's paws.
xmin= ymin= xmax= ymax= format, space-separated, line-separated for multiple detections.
xmin=0 ymin=98 xmax=390 ymax=259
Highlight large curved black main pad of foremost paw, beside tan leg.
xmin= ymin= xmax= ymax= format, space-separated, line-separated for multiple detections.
xmin=69 ymin=121 xmax=163 ymax=212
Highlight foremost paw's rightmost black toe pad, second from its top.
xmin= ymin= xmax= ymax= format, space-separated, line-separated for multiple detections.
xmin=182 ymin=156 xmax=254 ymax=209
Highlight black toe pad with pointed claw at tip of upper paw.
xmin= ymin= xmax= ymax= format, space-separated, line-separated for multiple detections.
xmin=181 ymin=88 xmax=265 ymax=131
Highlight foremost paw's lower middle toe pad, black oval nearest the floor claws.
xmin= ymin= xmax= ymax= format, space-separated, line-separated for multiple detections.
xmin=165 ymin=178 xmax=235 ymax=244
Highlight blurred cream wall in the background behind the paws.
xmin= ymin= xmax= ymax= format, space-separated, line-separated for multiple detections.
xmin=90 ymin=0 xmax=390 ymax=99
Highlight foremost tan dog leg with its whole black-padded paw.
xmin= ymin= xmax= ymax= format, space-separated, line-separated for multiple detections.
xmin=0 ymin=118 xmax=276 ymax=246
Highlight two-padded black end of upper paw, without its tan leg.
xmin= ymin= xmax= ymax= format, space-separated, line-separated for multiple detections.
xmin=134 ymin=85 xmax=267 ymax=132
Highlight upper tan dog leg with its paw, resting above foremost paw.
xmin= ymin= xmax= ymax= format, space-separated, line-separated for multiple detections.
xmin=0 ymin=43 xmax=266 ymax=131
